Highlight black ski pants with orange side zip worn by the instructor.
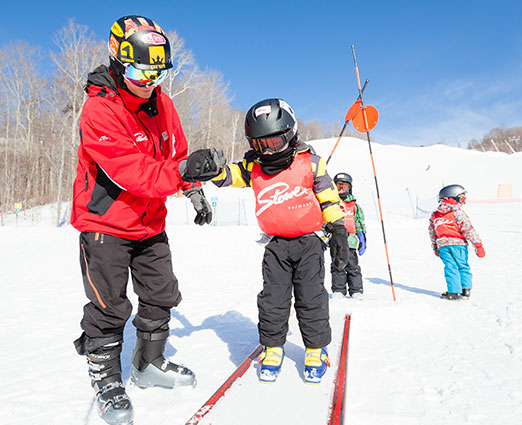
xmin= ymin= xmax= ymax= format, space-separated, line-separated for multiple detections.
xmin=80 ymin=232 xmax=181 ymax=339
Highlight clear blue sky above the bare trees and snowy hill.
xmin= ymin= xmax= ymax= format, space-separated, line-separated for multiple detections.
xmin=0 ymin=0 xmax=522 ymax=146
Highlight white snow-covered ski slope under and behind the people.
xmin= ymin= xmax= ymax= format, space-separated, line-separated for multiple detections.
xmin=0 ymin=138 xmax=522 ymax=425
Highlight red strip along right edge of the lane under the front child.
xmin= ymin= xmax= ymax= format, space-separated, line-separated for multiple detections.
xmin=328 ymin=314 xmax=350 ymax=425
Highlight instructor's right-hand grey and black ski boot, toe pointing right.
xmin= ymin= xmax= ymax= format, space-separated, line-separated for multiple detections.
xmin=130 ymin=316 xmax=196 ymax=388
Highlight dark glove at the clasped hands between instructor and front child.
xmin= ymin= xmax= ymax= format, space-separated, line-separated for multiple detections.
xmin=179 ymin=148 xmax=227 ymax=182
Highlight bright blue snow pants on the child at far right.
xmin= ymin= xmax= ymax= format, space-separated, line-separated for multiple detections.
xmin=439 ymin=245 xmax=472 ymax=294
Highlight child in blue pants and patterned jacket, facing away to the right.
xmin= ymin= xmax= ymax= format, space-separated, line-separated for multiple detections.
xmin=429 ymin=184 xmax=486 ymax=301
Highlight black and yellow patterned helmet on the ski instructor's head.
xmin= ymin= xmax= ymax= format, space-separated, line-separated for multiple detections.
xmin=109 ymin=15 xmax=173 ymax=70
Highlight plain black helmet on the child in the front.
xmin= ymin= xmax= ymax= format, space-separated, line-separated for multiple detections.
xmin=245 ymin=99 xmax=297 ymax=146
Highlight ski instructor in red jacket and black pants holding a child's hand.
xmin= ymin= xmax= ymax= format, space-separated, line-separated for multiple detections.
xmin=71 ymin=15 xmax=212 ymax=424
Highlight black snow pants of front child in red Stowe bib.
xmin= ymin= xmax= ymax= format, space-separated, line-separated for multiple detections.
xmin=257 ymin=234 xmax=332 ymax=348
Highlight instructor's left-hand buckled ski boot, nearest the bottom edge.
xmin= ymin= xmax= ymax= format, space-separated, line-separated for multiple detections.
xmin=87 ymin=341 xmax=133 ymax=425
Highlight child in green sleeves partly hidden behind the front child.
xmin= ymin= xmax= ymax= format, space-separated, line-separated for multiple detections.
xmin=330 ymin=173 xmax=366 ymax=299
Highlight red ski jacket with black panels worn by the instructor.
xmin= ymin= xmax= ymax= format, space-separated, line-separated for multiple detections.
xmin=71 ymin=65 xmax=191 ymax=240
